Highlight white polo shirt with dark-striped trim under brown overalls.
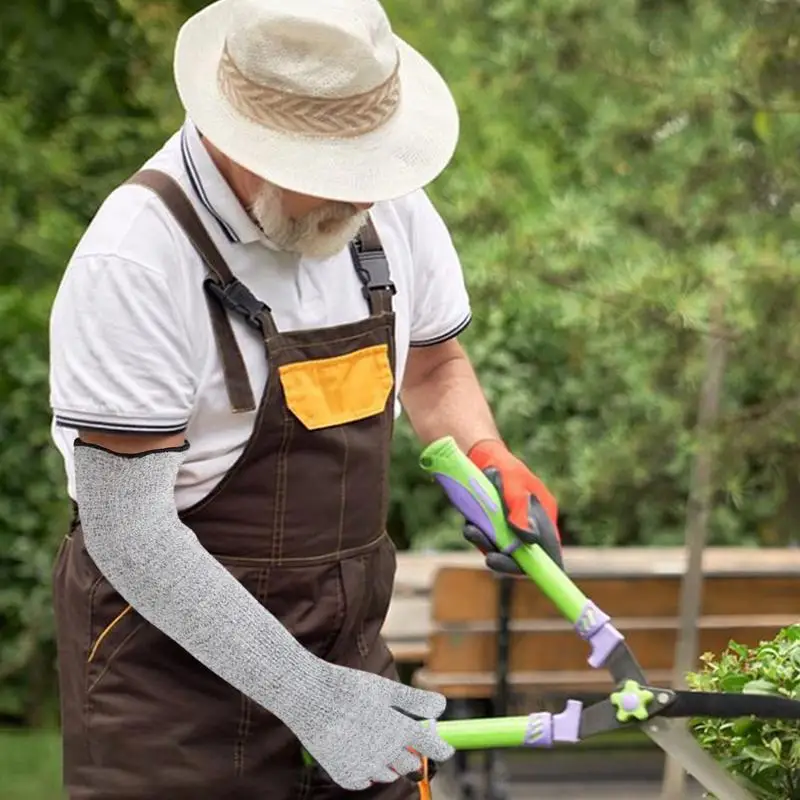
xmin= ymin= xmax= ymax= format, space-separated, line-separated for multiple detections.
xmin=50 ymin=121 xmax=471 ymax=509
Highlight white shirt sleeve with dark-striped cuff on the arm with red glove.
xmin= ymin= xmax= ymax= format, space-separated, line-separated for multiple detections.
xmin=411 ymin=191 xmax=472 ymax=347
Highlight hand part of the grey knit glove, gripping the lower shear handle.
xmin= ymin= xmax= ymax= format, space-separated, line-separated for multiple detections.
xmin=290 ymin=661 xmax=455 ymax=791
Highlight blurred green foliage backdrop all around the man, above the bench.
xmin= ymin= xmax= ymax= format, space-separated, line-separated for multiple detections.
xmin=0 ymin=0 xmax=800 ymax=800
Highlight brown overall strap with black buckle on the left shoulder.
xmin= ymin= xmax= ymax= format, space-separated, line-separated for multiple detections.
xmin=126 ymin=169 xmax=262 ymax=412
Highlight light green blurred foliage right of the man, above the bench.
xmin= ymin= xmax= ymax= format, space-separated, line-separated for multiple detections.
xmin=390 ymin=0 xmax=800 ymax=544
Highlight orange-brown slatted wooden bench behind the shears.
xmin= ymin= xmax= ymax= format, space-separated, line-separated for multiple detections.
xmin=413 ymin=566 xmax=800 ymax=798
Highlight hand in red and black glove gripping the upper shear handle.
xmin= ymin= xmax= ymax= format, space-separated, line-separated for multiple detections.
xmin=463 ymin=439 xmax=564 ymax=575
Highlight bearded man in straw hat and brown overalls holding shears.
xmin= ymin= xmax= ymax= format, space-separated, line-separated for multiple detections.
xmin=51 ymin=0 xmax=559 ymax=800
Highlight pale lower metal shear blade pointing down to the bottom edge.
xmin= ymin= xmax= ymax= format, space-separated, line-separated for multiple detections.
xmin=642 ymin=717 xmax=755 ymax=800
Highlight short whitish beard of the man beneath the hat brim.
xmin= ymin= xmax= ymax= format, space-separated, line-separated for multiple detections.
xmin=251 ymin=183 xmax=367 ymax=258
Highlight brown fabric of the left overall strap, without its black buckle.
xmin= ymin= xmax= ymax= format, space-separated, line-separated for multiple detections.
xmin=126 ymin=169 xmax=256 ymax=413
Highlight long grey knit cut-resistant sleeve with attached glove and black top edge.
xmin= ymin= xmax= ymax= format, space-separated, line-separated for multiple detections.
xmin=75 ymin=440 xmax=453 ymax=790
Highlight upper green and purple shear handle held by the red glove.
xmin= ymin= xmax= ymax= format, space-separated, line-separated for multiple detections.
xmin=420 ymin=436 xmax=589 ymax=625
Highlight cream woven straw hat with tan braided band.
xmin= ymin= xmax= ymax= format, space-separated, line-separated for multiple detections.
xmin=174 ymin=0 xmax=458 ymax=203
